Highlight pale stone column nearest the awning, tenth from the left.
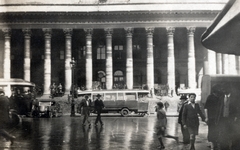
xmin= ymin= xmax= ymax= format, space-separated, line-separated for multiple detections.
xmin=187 ymin=27 xmax=196 ymax=89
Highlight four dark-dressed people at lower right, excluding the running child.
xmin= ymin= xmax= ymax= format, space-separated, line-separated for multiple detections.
xmin=174 ymin=83 xmax=240 ymax=150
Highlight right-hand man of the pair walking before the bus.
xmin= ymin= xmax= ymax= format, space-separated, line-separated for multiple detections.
xmin=94 ymin=94 xmax=104 ymax=126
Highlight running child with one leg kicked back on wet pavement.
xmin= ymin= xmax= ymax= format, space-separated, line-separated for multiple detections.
xmin=155 ymin=102 xmax=178 ymax=149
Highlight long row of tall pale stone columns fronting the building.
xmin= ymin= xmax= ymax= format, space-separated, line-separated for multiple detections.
xmin=2 ymin=27 xmax=240 ymax=94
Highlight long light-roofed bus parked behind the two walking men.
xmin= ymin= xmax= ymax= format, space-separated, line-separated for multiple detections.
xmin=77 ymin=90 xmax=150 ymax=116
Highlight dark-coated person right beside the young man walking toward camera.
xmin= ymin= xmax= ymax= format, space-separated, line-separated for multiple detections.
xmin=204 ymin=85 xmax=222 ymax=149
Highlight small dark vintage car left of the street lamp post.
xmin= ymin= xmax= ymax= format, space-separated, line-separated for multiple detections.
xmin=31 ymin=99 xmax=63 ymax=118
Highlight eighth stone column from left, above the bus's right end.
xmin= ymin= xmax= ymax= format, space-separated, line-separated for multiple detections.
xmin=145 ymin=28 xmax=154 ymax=92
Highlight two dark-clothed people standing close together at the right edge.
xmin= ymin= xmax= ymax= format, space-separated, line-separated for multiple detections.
xmin=205 ymin=83 xmax=240 ymax=150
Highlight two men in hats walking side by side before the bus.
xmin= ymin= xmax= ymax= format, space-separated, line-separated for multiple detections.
xmin=79 ymin=94 xmax=104 ymax=127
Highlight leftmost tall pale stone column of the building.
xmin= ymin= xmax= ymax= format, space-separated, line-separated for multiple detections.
xmin=2 ymin=28 xmax=11 ymax=79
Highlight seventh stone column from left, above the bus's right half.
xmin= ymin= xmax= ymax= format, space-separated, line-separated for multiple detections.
xmin=125 ymin=28 xmax=133 ymax=89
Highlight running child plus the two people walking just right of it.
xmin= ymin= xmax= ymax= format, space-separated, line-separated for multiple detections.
xmin=156 ymin=93 xmax=205 ymax=150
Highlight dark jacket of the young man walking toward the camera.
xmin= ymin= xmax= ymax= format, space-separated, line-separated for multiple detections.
xmin=182 ymin=103 xmax=205 ymax=129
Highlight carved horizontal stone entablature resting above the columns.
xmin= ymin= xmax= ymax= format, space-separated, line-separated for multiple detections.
xmin=0 ymin=11 xmax=219 ymax=29
